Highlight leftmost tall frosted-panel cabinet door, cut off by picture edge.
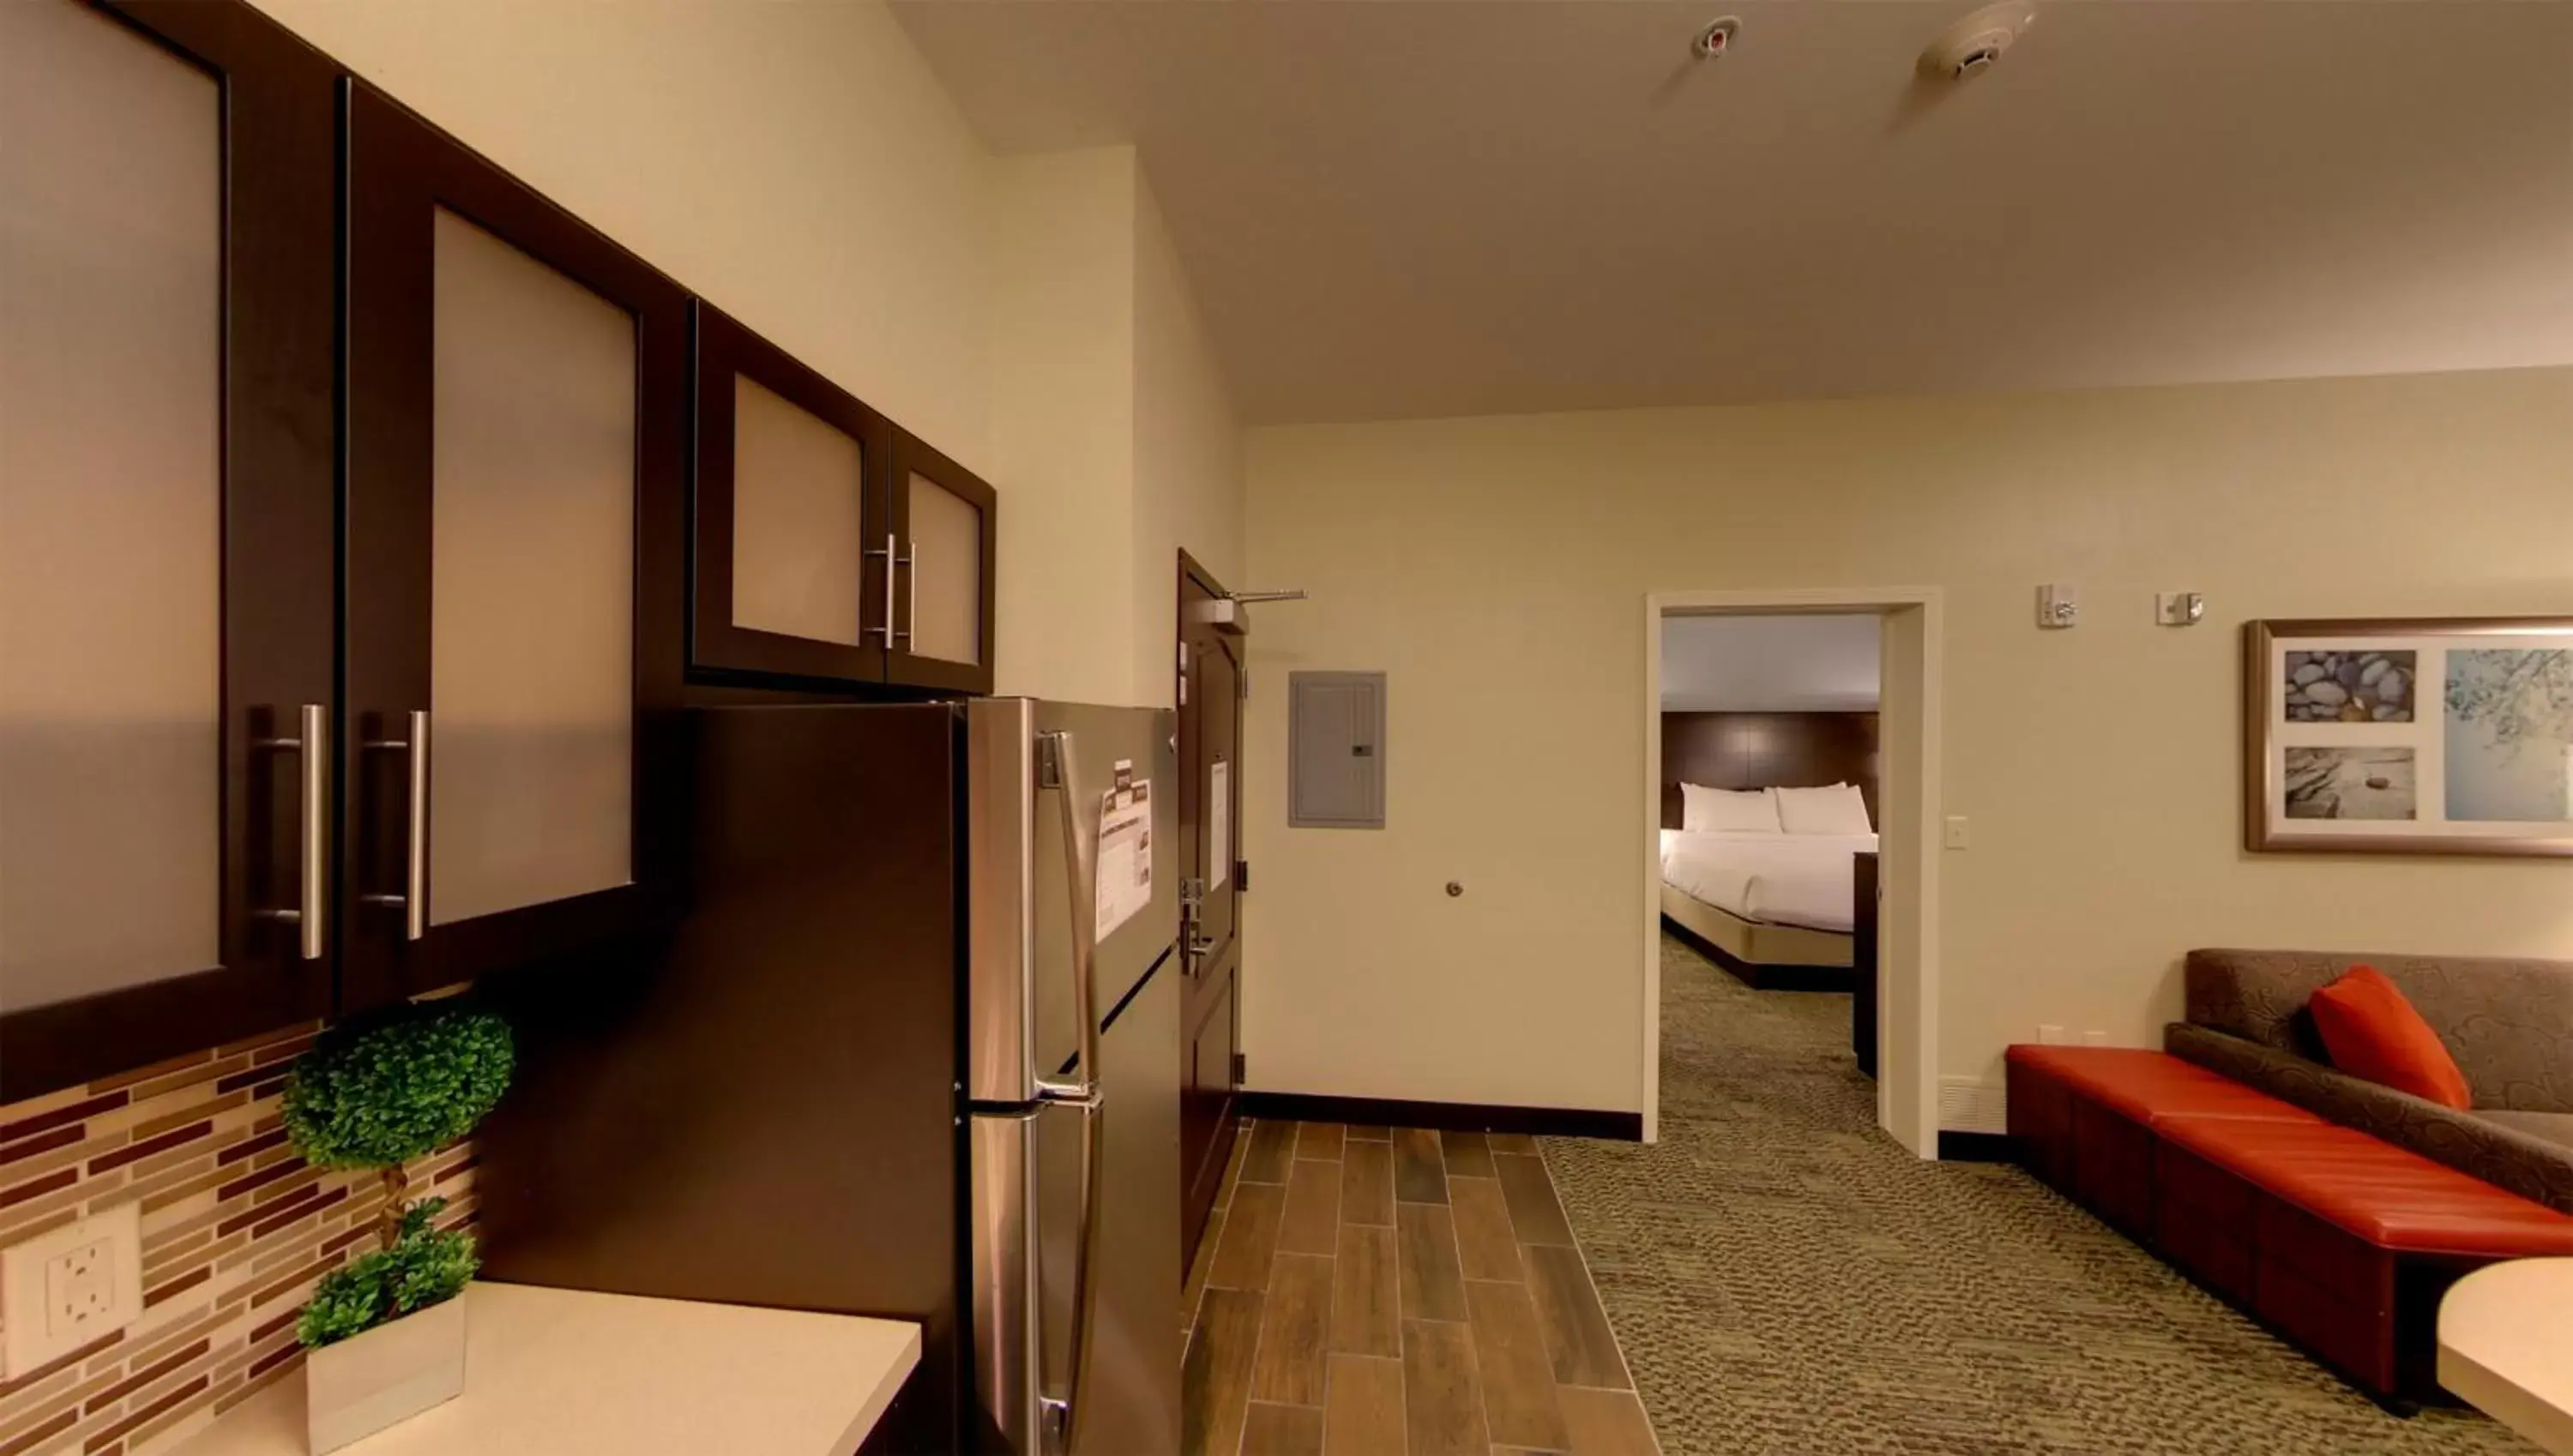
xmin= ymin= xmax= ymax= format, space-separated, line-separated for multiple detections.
xmin=0 ymin=0 xmax=337 ymax=1101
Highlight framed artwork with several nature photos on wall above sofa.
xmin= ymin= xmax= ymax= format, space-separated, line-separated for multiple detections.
xmin=2244 ymin=615 xmax=2573 ymax=857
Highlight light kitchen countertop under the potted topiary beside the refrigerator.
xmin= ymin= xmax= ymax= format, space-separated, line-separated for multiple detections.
xmin=175 ymin=1284 xmax=921 ymax=1456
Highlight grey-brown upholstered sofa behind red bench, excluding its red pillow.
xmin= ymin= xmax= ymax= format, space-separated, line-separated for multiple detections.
xmin=2161 ymin=949 xmax=2573 ymax=1214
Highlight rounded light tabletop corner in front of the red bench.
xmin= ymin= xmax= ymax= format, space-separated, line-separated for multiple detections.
xmin=2439 ymin=1258 xmax=2573 ymax=1456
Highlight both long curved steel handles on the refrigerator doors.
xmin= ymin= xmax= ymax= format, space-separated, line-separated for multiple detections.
xmin=1037 ymin=731 xmax=1106 ymax=1453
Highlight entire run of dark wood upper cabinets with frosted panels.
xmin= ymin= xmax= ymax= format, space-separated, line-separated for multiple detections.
xmin=0 ymin=0 xmax=993 ymax=1101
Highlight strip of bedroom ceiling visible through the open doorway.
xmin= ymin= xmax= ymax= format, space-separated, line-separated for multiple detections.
xmin=1662 ymin=617 xmax=1883 ymax=713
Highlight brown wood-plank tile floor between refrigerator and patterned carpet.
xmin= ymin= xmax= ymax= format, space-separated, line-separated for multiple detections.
xmin=1178 ymin=1122 xmax=1660 ymax=1456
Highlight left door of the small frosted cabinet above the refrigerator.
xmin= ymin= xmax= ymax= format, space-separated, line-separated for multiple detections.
xmin=690 ymin=301 xmax=895 ymax=682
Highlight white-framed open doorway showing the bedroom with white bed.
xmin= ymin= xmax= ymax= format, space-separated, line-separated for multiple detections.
xmin=1644 ymin=589 xmax=1940 ymax=1158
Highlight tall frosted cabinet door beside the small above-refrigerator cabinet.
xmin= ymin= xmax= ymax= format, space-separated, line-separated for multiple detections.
xmin=340 ymin=85 xmax=687 ymax=1011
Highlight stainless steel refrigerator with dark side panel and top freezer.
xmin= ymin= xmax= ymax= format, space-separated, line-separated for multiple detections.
xmin=476 ymin=700 xmax=1181 ymax=1456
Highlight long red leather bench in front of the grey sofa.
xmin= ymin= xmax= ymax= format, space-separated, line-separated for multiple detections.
xmin=2010 ymin=1047 xmax=2573 ymax=1410
